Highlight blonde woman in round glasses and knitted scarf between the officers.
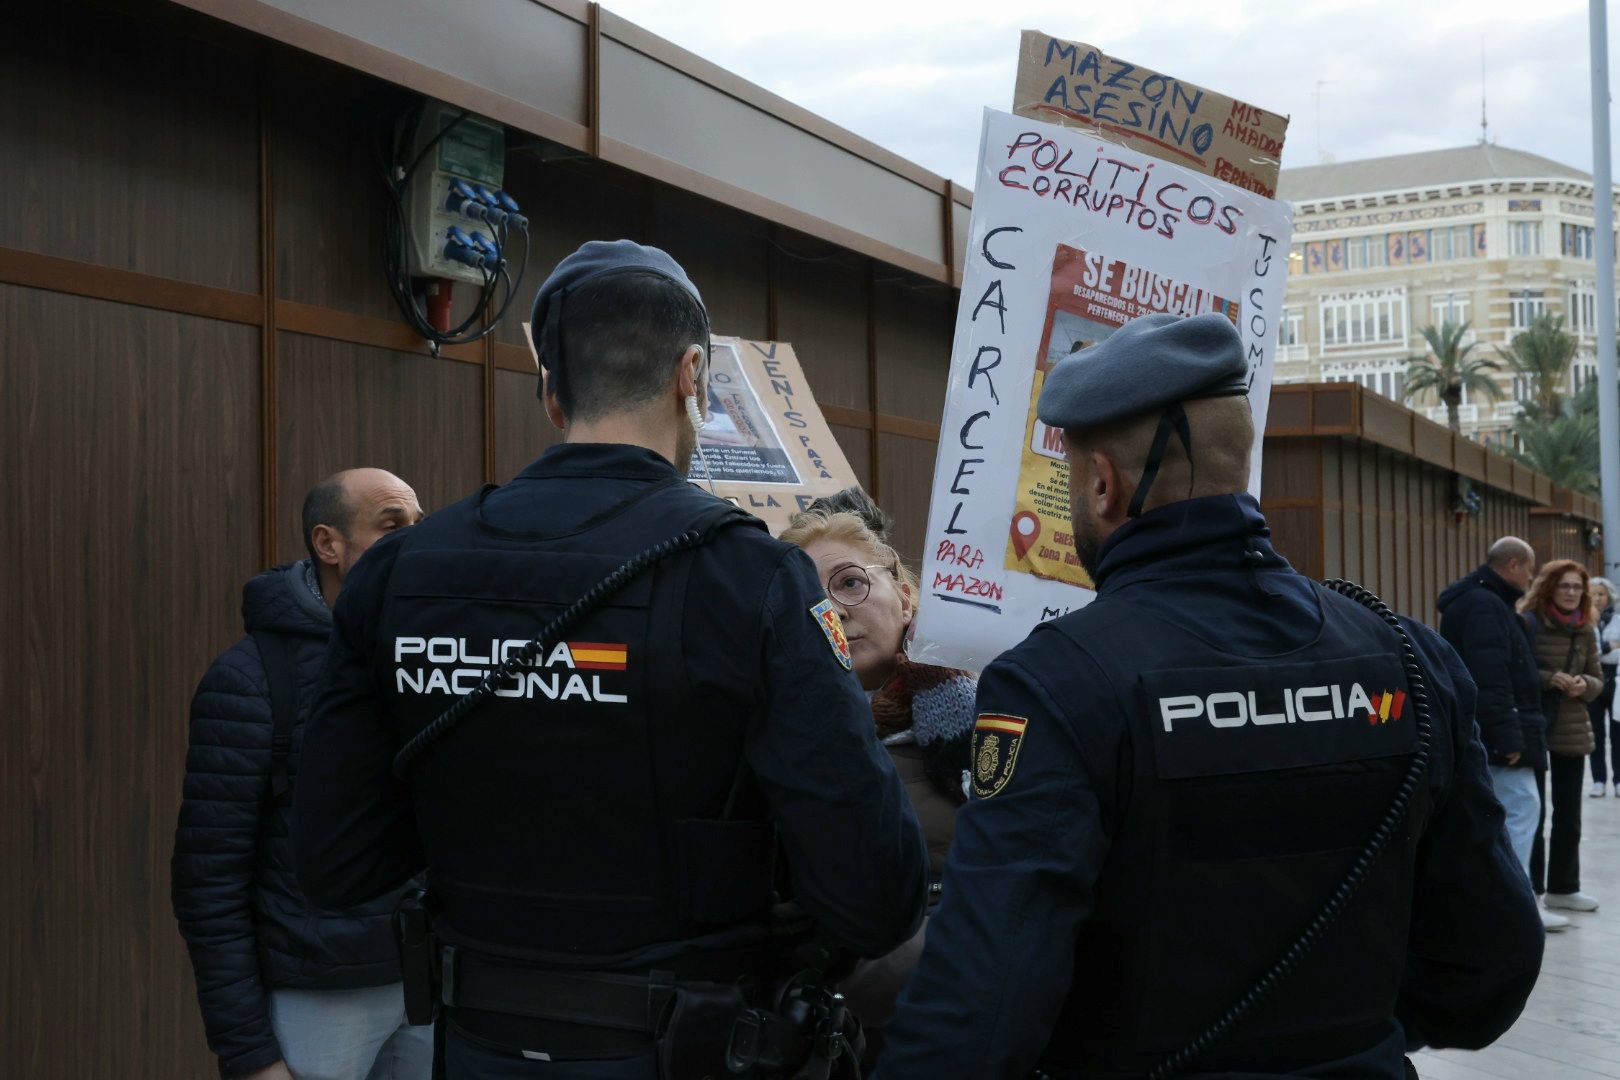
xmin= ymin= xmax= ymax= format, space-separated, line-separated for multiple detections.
xmin=782 ymin=487 xmax=977 ymax=1057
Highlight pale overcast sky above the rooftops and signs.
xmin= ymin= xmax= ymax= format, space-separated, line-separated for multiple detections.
xmin=606 ymin=0 xmax=1620 ymax=186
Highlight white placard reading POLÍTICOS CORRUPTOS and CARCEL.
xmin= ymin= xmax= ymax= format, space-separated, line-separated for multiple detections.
xmin=912 ymin=110 xmax=1293 ymax=670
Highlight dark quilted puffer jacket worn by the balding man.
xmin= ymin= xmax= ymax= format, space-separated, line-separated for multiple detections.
xmin=170 ymin=562 xmax=400 ymax=1077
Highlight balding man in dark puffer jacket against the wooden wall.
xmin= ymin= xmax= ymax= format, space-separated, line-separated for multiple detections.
xmin=170 ymin=468 xmax=433 ymax=1080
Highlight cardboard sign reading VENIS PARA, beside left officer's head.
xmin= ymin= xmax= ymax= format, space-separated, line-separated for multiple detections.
xmin=690 ymin=337 xmax=855 ymax=533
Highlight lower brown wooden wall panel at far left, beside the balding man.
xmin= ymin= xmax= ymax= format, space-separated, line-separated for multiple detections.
xmin=0 ymin=285 xmax=261 ymax=1080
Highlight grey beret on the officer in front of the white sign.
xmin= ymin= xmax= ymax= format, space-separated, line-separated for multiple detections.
xmin=1035 ymin=313 xmax=1249 ymax=427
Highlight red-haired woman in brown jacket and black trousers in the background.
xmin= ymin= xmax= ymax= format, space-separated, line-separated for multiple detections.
xmin=1520 ymin=559 xmax=1604 ymax=912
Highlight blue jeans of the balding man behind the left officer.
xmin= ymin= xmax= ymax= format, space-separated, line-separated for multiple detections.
xmin=271 ymin=983 xmax=433 ymax=1080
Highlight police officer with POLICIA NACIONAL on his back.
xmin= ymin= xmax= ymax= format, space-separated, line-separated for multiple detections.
xmin=295 ymin=240 xmax=928 ymax=1080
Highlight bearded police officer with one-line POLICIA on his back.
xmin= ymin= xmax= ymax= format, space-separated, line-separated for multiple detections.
xmin=880 ymin=307 xmax=1542 ymax=1080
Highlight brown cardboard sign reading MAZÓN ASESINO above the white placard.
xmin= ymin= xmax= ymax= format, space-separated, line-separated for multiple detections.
xmin=1013 ymin=31 xmax=1288 ymax=198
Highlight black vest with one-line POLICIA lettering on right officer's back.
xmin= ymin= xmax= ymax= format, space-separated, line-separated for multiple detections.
xmin=1045 ymin=586 xmax=1429 ymax=1075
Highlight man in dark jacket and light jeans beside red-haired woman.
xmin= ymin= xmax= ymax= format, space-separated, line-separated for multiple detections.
xmin=1439 ymin=536 xmax=1570 ymax=931
